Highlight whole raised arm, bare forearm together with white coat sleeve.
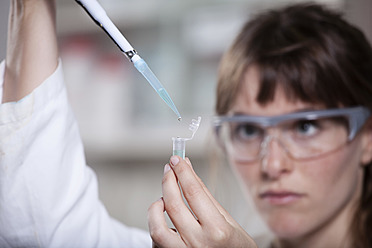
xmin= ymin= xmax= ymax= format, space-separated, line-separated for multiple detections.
xmin=0 ymin=0 xmax=151 ymax=248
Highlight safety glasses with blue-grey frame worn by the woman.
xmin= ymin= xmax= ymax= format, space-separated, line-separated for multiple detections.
xmin=214 ymin=106 xmax=370 ymax=162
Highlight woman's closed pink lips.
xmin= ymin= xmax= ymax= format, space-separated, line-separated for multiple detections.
xmin=259 ymin=191 xmax=304 ymax=205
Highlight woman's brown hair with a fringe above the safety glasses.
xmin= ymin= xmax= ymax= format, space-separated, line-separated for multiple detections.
xmin=216 ymin=3 xmax=372 ymax=247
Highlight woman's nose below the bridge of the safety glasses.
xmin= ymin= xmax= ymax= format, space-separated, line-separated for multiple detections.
xmin=260 ymin=136 xmax=293 ymax=179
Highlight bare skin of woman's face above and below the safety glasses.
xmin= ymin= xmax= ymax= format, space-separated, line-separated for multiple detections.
xmin=230 ymin=66 xmax=370 ymax=239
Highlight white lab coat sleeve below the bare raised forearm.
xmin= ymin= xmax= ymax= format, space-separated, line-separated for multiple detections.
xmin=0 ymin=61 xmax=151 ymax=248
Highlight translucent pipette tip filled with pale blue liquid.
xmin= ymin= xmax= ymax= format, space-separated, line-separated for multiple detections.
xmin=134 ymin=59 xmax=181 ymax=121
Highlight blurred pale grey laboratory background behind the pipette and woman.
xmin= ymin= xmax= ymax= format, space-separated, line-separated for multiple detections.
xmin=0 ymin=0 xmax=372 ymax=238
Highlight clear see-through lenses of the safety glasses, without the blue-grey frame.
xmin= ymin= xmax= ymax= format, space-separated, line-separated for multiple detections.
xmin=220 ymin=117 xmax=349 ymax=162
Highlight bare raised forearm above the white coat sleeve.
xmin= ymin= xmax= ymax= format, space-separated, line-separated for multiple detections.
xmin=2 ymin=0 xmax=58 ymax=103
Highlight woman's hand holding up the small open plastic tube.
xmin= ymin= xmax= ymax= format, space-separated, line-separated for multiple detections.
xmin=148 ymin=156 xmax=257 ymax=248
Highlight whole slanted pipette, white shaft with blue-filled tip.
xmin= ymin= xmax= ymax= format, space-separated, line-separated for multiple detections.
xmin=76 ymin=0 xmax=181 ymax=121
